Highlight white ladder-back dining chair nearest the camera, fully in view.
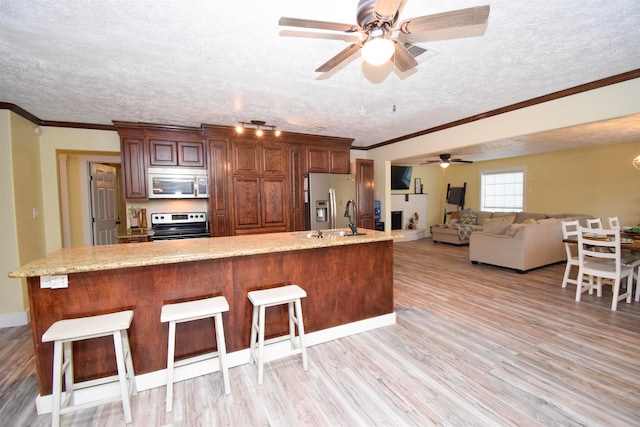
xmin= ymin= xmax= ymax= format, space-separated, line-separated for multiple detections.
xmin=576 ymin=227 xmax=633 ymax=311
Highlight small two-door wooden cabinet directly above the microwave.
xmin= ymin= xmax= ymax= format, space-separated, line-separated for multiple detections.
xmin=149 ymin=139 xmax=205 ymax=168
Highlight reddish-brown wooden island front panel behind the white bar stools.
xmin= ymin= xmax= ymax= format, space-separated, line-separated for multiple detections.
xmin=28 ymin=240 xmax=393 ymax=396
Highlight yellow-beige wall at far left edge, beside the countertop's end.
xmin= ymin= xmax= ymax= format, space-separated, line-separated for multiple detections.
xmin=0 ymin=110 xmax=45 ymax=326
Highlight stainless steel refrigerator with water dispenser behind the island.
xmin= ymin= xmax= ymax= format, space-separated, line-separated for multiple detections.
xmin=304 ymin=173 xmax=356 ymax=230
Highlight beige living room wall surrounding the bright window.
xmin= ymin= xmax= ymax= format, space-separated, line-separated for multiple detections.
xmin=418 ymin=141 xmax=640 ymax=225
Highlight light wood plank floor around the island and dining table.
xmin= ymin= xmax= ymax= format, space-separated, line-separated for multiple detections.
xmin=0 ymin=239 xmax=640 ymax=426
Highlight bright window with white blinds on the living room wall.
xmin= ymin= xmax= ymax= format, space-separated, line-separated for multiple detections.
xmin=480 ymin=169 xmax=524 ymax=212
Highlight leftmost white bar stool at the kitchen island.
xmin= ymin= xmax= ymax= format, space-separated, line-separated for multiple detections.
xmin=42 ymin=310 xmax=137 ymax=427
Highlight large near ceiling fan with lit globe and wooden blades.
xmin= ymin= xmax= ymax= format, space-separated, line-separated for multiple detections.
xmin=278 ymin=0 xmax=489 ymax=72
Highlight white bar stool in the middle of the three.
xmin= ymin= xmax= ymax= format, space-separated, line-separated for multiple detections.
xmin=160 ymin=297 xmax=231 ymax=412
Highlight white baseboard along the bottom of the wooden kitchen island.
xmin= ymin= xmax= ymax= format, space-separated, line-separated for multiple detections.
xmin=36 ymin=313 xmax=396 ymax=415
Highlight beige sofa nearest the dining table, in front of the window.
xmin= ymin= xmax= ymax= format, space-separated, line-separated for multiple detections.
xmin=469 ymin=214 xmax=591 ymax=273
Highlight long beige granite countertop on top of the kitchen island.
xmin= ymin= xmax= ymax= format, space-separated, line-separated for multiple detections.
xmin=8 ymin=229 xmax=401 ymax=278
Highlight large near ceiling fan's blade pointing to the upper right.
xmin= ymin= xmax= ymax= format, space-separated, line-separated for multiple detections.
xmin=401 ymin=5 xmax=490 ymax=33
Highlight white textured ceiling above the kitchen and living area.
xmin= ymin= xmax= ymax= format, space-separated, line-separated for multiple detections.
xmin=0 ymin=0 xmax=640 ymax=160
